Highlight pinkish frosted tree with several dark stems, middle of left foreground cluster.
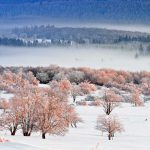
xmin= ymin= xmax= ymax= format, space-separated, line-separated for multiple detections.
xmin=12 ymin=85 xmax=41 ymax=136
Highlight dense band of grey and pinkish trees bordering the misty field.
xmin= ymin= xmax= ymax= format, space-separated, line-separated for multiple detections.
xmin=0 ymin=65 xmax=150 ymax=95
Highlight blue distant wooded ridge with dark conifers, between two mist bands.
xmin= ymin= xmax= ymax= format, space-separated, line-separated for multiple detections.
xmin=0 ymin=25 xmax=150 ymax=50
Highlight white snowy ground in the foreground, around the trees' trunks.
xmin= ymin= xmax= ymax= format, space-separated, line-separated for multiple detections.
xmin=0 ymin=103 xmax=150 ymax=150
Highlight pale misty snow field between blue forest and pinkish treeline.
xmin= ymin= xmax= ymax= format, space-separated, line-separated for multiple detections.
xmin=0 ymin=47 xmax=150 ymax=71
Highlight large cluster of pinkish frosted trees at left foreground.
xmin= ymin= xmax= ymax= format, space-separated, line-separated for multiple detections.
xmin=0 ymin=72 xmax=81 ymax=139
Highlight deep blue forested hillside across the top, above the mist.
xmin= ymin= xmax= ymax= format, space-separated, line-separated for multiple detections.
xmin=0 ymin=0 xmax=150 ymax=23
